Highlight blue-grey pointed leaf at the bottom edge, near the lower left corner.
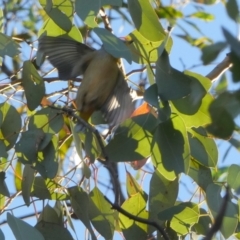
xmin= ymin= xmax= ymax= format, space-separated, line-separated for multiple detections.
xmin=7 ymin=213 xmax=44 ymax=240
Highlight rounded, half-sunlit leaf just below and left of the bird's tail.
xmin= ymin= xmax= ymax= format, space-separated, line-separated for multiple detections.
xmin=28 ymin=107 xmax=64 ymax=134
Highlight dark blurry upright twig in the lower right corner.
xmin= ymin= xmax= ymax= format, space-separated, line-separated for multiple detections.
xmin=204 ymin=187 xmax=229 ymax=240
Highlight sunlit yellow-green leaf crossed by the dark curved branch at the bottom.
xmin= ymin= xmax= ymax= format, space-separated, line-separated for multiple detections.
xmin=119 ymin=193 xmax=148 ymax=240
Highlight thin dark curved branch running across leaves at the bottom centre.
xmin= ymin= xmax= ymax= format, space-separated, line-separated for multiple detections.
xmin=104 ymin=196 xmax=169 ymax=240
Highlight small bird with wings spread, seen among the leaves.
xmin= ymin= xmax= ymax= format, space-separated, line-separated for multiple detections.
xmin=39 ymin=36 xmax=134 ymax=127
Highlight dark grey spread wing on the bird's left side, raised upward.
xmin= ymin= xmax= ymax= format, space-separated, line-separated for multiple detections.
xmin=39 ymin=36 xmax=95 ymax=80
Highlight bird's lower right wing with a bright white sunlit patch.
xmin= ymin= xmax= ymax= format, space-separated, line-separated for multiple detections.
xmin=101 ymin=70 xmax=134 ymax=127
